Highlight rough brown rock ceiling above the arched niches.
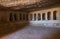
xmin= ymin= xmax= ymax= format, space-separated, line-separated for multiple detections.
xmin=0 ymin=0 xmax=60 ymax=10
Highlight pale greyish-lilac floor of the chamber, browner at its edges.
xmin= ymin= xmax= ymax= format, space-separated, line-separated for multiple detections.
xmin=0 ymin=26 xmax=60 ymax=39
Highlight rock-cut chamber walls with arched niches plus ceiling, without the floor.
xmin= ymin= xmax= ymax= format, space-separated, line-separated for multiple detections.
xmin=0 ymin=0 xmax=60 ymax=36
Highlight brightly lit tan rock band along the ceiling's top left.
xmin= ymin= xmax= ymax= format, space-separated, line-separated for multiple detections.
xmin=0 ymin=0 xmax=41 ymax=7
